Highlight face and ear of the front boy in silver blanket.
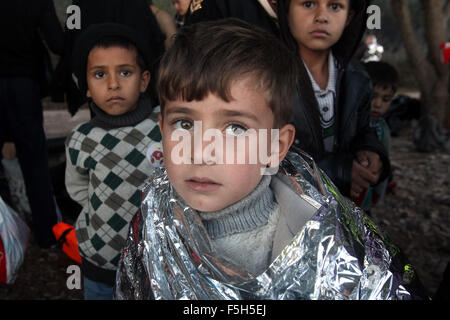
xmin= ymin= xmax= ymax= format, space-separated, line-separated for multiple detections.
xmin=160 ymin=80 xmax=295 ymax=212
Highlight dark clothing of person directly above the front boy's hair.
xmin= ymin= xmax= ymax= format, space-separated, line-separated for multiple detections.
xmin=185 ymin=0 xmax=278 ymax=35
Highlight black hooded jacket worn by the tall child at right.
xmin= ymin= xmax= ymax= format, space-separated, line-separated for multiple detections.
xmin=278 ymin=0 xmax=390 ymax=196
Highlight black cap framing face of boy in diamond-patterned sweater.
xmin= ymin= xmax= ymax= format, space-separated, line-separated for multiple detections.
xmin=72 ymin=23 xmax=151 ymax=95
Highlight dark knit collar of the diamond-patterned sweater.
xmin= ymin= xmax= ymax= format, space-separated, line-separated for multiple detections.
xmin=89 ymin=95 xmax=153 ymax=130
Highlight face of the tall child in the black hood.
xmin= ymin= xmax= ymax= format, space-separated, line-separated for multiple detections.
xmin=288 ymin=0 xmax=353 ymax=51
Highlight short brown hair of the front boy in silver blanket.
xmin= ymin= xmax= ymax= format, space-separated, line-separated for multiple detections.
xmin=157 ymin=18 xmax=297 ymax=127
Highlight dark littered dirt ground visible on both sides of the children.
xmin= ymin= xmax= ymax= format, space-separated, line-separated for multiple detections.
xmin=0 ymin=122 xmax=450 ymax=300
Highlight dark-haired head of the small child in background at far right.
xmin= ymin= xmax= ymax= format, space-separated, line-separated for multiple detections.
xmin=365 ymin=61 xmax=398 ymax=118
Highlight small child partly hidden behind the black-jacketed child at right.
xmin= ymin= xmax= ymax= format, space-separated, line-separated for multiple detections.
xmin=355 ymin=62 xmax=398 ymax=214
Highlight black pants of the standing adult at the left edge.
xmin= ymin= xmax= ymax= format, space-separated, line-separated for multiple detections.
xmin=0 ymin=77 xmax=58 ymax=248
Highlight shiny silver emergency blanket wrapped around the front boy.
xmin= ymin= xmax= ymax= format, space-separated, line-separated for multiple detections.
xmin=115 ymin=152 xmax=424 ymax=300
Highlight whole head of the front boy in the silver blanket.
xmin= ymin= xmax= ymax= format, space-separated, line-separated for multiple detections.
xmin=157 ymin=19 xmax=296 ymax=212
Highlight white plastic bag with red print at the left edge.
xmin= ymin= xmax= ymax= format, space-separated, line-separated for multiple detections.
xmin=0 ymin=197 xmax=30 ymax=284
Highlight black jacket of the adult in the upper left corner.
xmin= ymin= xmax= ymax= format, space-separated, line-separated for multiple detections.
xmin=0 ymin=0 xmax=64 ymax=94
